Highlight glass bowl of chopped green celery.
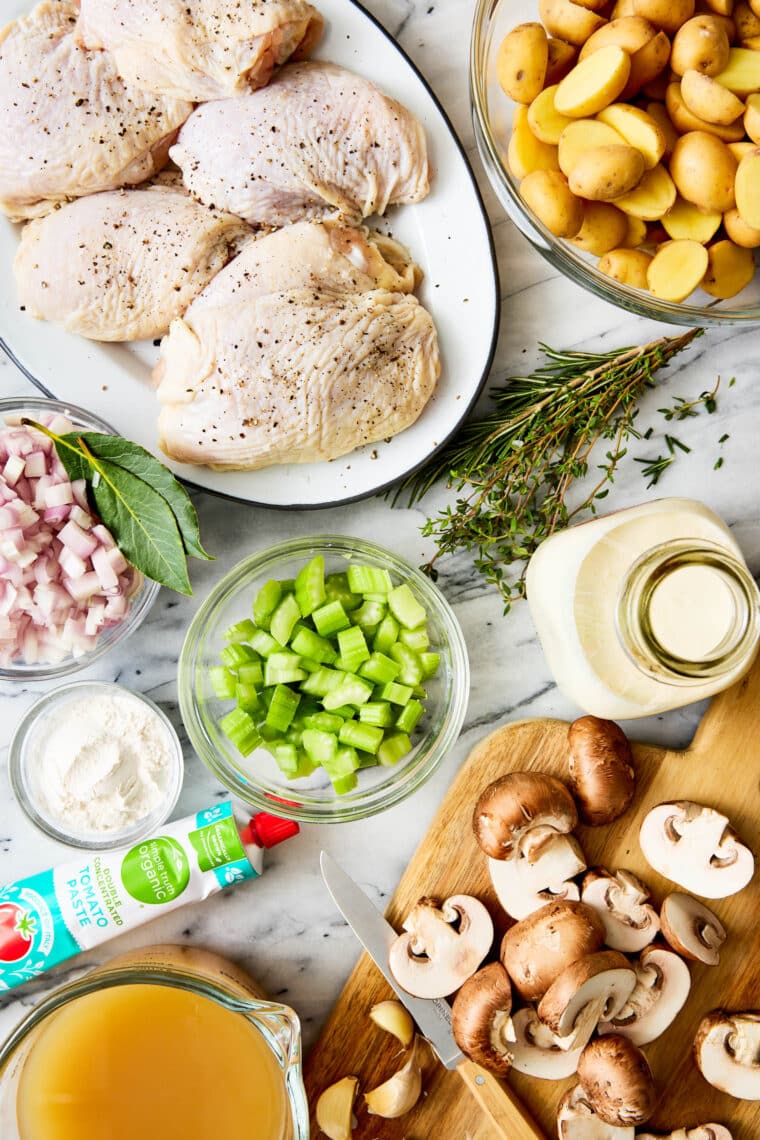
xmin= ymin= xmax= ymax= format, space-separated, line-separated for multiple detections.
xmin=179 ymin=535 xmax=469 ymax=823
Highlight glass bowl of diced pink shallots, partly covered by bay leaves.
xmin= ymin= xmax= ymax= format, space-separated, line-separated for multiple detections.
xmin=0 ymin=397 xmax=160 ymax=681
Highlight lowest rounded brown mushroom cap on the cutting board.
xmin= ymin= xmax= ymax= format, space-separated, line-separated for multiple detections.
xmin=578 ymin=1033 xmax=656 ymax=1125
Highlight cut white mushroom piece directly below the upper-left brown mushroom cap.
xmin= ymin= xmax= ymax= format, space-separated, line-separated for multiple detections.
xmin=488 ymin=832 xmax=586 ymax=919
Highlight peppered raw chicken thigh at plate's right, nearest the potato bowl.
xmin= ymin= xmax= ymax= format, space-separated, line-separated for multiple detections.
xmin=170 ymin=62 xmax=430 ymax=226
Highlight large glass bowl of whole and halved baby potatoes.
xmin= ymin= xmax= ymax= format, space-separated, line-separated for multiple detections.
xmin=471 ymin=0 xmax=760 ymax=325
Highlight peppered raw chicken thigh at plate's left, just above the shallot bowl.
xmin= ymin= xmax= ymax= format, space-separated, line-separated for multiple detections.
xmin=14 ymin=186 xmax=248 ymax=341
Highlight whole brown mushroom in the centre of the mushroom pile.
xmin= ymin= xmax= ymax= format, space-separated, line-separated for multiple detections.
xmin=501 ymin=901 xmax=604 ymax=1001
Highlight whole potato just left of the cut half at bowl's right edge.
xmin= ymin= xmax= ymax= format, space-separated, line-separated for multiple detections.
xmin=670 ymin=131 xmax=738 ymax=210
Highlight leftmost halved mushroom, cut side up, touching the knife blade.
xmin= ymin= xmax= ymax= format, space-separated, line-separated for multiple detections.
xmin=389 ymin=895 xmax=493 ymax=998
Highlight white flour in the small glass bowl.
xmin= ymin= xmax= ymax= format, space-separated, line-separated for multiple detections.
xmin=28 ymin=693 xmax=174 ymax=832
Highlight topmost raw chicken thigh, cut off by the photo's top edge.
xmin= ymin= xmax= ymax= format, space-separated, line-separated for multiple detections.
xmin=77 ymin=0 xmax=324 ymax=103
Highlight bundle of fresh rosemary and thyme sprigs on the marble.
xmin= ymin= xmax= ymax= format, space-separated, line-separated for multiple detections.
xmin=393 ymin=328 xmax=703 ymax=612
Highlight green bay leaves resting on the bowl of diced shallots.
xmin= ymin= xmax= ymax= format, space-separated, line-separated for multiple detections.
xmin=23 ymin=420 xmax=212 ymax=594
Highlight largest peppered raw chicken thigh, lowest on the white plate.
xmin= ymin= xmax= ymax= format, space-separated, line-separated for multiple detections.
xmin=155 ymin=222 xmax=440 ymax=470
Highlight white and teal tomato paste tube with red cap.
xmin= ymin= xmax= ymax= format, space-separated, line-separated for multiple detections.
xmin=0 ymin=803 xmax=299 ymax=991
